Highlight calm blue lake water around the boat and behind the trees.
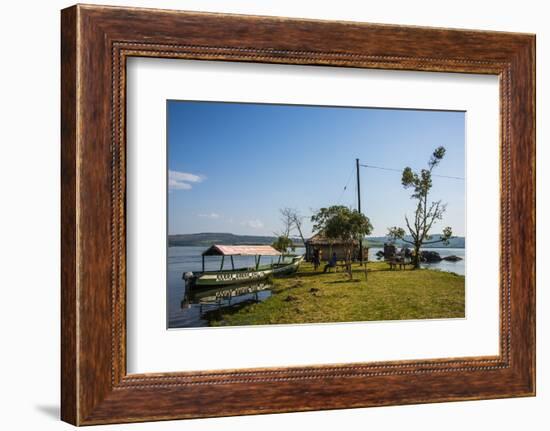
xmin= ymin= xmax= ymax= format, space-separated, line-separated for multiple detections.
xmin=167 ymin=247 xmax=465 ymax=328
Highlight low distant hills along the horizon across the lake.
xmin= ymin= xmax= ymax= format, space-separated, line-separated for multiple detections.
xmin=168 ymin=232 xmax=466 ymax=248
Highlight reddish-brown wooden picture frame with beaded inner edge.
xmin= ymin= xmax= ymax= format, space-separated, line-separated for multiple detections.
xmin=61 ymin=5 xmax=535 ymax=425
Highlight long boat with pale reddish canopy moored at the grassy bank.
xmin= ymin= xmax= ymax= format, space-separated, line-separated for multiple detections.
xmin=182 ymin=244 xmax=304 ymax=288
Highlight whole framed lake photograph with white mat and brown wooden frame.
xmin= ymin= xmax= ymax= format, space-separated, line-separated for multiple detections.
xmin=61 ymin=5 xmax=535 ymax=425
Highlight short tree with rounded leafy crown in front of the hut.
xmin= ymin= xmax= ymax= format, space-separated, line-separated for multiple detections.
xmin=311 ymin=205 xmax=372 ymax=279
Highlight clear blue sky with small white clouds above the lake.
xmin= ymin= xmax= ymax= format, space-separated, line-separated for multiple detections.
xmin=167 ymin=101 xmax=465 ymax=235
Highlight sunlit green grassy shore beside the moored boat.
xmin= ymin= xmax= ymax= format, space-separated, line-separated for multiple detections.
xmin=207 ymin=262 xmax=464 ymax=326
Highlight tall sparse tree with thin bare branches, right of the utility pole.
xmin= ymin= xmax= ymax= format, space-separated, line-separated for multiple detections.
xmin=388 ymin=147 xmax=453 ymax=268
